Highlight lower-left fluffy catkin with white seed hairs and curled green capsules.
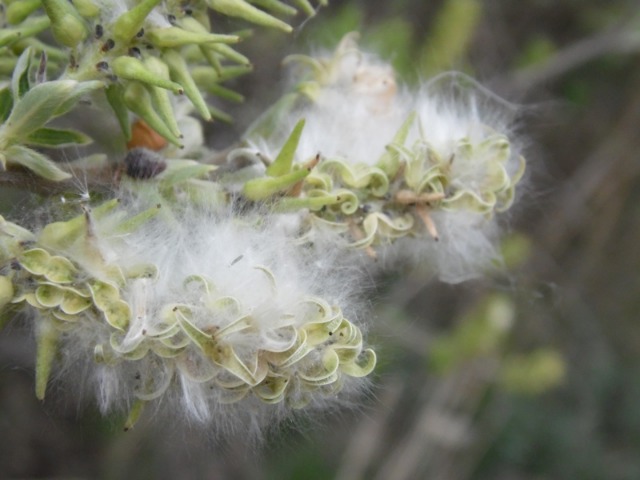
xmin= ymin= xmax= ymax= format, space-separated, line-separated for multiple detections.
xmin=8 ymin=189 xmax=375 ymax=434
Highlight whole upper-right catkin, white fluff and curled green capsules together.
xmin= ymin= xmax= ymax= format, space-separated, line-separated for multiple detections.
xmin=240 ymin=36 xmax=525 ymax=282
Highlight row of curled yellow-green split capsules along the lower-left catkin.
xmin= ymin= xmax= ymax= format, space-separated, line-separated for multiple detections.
xmin=0 ymin=204 xmax=376 ymax=408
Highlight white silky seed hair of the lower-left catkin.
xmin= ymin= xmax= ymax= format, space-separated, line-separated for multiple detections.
xmin=48 ymin=198 xmax=376 ymax=438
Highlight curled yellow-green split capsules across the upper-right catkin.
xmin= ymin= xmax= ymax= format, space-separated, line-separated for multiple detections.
xmin=245 ymin=109 xmax=525 ymax=254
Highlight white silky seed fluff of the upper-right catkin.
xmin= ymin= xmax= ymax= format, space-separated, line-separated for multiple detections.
xmin=248 ymin=41 xmax=523 ymax=282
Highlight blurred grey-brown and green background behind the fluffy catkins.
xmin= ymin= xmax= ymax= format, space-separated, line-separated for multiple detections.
xmin=0 ymin=0 xmax=640 ymax=480
